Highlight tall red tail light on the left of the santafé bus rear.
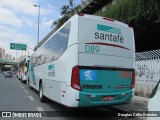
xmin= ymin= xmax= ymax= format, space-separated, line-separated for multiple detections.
xmin=71 ymin=66 xmax=81 ymax=90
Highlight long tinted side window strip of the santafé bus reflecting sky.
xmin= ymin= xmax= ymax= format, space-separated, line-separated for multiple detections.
xmin=33 ymin=23 xmax=71 ymax=66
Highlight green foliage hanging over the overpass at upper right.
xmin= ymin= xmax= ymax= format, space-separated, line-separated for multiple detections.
xmin=97 ymin=0 xmax=160 ymax=24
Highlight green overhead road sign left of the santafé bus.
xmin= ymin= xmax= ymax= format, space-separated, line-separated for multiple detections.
xmin=10 ymin=43 xmax=27 ymax=50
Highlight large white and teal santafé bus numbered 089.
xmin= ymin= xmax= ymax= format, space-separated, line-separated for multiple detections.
xmin=28 ymin=14 xmax=135 ymax=107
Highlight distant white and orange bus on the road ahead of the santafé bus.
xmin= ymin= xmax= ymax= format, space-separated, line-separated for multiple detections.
xmin=17 ymin=56 xmax=29 ymax=82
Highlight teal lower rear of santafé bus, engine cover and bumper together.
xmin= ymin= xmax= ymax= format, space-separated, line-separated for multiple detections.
xmin=76 ymin=67 xmax=134 ymax=106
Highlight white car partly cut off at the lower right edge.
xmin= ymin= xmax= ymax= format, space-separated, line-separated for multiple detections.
xmin=147 ymin=80 xmax=160 ymax=120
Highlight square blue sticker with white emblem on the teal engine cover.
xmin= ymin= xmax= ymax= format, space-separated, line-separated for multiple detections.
xmin=80 ymin=70 xmax=97 ymax=80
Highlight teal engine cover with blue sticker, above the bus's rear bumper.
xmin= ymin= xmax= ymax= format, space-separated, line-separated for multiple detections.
xmin=79 ymin=67 xmax=133 ymax=93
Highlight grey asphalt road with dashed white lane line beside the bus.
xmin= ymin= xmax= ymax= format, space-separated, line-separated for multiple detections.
xmin=0 ymin=73 xmax=135 ymax=120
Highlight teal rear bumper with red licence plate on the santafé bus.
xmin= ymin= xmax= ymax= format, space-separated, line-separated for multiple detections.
xmin=78 ymin=90 xmax=134 ymax=107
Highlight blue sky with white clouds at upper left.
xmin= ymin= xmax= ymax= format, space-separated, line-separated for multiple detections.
xmin=0 ymin=0 xmax=81 ymax=58
